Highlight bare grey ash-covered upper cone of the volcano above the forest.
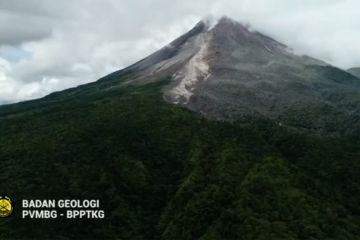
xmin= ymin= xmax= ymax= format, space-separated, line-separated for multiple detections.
xmin=110 ymin=17 xmax=360 ymax=132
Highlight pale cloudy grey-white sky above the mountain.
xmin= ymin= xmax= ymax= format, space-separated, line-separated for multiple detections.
xmin=0 ymin=0 xmax=360 ymax=104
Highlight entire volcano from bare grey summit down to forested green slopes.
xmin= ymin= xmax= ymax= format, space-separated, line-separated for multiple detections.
xmin=0 ymin=17 xmax=360 ymax=240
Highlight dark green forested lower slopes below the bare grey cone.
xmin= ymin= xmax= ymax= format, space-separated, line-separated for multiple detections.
xmin=0 ymin=78 xmax=360 ymax=240
